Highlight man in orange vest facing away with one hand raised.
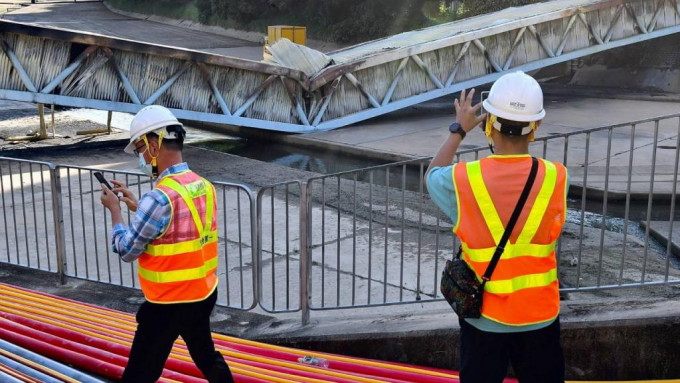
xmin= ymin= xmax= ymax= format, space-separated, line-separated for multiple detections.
xmin=425 ymin=72 xmax=568 ymax=383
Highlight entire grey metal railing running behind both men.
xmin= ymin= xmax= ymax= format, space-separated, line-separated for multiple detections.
xmin=0 ymin=114 xmax=680 ymax=322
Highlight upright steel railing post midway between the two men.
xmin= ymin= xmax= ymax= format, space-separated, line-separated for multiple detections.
xmin=300 ymin=182 xmax=312 ymax=326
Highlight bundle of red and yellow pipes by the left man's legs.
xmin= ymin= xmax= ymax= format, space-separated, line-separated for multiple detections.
xmin=0 ymin=283 xmax=472 ymax=383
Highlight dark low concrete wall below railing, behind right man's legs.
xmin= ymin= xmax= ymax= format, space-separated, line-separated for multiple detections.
xmin=258 ymin=315 xmax=680 ymax=380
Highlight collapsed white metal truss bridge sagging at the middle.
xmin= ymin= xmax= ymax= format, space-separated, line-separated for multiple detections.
xmin=0 ymin=0 xmax=680 ymax=133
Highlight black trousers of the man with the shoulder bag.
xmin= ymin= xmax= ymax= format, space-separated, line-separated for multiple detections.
xmin=459 ymin=317 xmax=564 ymax=383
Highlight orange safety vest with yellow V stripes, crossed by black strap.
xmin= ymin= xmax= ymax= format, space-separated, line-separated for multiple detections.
xmin=452 ymin=155 xmax=567 ymax=326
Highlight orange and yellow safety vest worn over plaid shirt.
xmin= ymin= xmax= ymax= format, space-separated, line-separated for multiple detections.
xmin=137 ymin=170 xmax=217 ymax=303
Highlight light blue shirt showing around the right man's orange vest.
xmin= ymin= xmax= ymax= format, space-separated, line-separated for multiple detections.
xmin=427 ymin=154 xmax=569 ymax=333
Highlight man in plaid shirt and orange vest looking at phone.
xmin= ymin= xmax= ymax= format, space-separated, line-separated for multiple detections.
xmin=101 ymin=105 xmax=234 ymax=382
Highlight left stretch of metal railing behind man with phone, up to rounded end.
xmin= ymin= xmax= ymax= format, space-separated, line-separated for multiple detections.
xmin=0 ymin=157 xmax=258 ymax=310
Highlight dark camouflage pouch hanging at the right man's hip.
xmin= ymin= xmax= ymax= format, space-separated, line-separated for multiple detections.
xmin=439 ymin=249 xmax=484 ymax=318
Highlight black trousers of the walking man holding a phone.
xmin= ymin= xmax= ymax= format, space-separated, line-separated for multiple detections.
xmin=122 ymin=291 xmax=234 ymax=383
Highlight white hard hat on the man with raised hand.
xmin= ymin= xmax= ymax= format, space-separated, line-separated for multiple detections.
xmin=483 ymin=71 xmax=545 ymax=122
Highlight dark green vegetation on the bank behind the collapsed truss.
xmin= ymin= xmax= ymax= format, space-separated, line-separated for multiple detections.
xmin=107 ymin=0 xmax=539 ymax=43
